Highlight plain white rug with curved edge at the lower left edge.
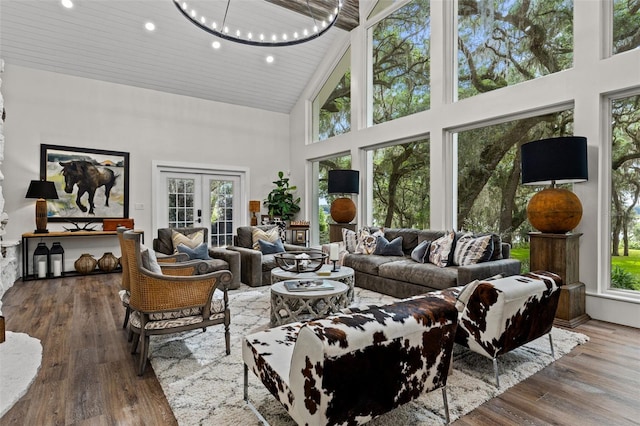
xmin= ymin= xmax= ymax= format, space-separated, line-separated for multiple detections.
xmin=0 ymin=331 xmax=42 ymax=417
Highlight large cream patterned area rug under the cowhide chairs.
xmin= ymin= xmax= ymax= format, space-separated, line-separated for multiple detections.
xmin=150 ymin=285 xmax=588 ymax=426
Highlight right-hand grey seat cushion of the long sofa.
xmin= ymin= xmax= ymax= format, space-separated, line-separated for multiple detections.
xmin=378 ymin=258 xmax=458 ymax=291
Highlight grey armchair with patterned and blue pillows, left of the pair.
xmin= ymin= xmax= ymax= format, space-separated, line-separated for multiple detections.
xmin=153 ymin=227 xmax=240 ymax=290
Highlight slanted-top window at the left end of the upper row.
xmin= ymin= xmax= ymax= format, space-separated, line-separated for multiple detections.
xmin=312 ymin=48 xmax=351 ymax=142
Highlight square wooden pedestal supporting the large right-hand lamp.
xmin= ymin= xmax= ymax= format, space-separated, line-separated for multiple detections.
xmin=529 ymin=232 xmax=591 ymax=328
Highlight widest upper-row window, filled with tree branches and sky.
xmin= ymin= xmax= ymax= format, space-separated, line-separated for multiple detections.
xmin=458 ymin=0 xmax=573 ymax=99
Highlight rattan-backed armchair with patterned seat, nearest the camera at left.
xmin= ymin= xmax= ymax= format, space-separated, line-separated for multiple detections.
xmin=122 ymin=231 xmax=233 ymax=375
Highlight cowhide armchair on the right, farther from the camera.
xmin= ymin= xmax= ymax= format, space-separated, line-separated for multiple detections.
xmin=452 ymin=271 xmax=562 ymax=387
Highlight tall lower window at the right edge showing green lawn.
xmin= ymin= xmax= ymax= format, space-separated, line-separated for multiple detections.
xmin=611 ymin=95 xmax=640 ymax=291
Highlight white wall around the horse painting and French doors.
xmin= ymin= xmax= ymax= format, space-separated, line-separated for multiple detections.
xmin=2 ymin=63 xmax=290 ymax=269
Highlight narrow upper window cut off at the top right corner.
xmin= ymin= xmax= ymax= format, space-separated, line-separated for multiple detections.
xmin=613 ymin=0 xmax=640 ymax=54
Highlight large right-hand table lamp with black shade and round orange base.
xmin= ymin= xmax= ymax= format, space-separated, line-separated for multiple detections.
xmin=521 ymin=136 xmax=588 ymax=234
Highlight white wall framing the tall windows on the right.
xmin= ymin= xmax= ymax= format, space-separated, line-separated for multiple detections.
xmin=291 ymin=1 xmax=640 ymax=327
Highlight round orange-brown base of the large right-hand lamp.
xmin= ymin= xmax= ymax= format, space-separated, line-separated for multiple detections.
xmin=527 ymin=188 xmax=582 ymax=234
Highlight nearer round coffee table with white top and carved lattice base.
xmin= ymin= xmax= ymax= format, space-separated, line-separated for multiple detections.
xmin=271 ymin=280 xmax=349 ymax=326
